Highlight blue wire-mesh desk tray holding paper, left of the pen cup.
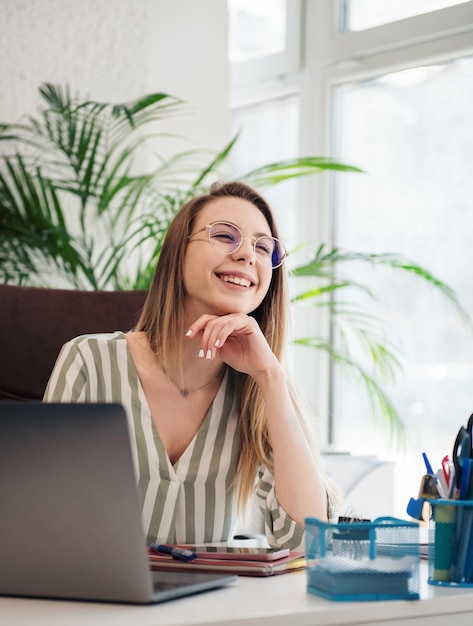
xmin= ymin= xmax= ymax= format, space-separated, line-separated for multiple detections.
xmin=305 ymin=517 xmax=420 ymax=601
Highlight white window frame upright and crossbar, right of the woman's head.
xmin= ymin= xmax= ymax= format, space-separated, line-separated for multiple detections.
xmin=230 ymin=0 xmax=473 ymax=444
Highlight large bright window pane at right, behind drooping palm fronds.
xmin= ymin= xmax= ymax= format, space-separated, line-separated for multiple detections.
xmin=332 ymin=58 xmax=473 ymax=515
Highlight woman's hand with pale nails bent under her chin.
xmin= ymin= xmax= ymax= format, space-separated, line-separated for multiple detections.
xmin=187 ymin=313 xmax=279 ymax=380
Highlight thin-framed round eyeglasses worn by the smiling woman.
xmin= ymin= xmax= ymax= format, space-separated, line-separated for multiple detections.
xmin=188 ymin=222 xmax=288 ymax=269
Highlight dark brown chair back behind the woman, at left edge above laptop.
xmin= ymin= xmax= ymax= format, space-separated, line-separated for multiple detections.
xmin=0 ymin=285 xmax=146 ymax=401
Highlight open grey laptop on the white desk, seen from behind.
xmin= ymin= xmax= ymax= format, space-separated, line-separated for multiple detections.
xmin=0 ymin=402 xmax=236 ymax=604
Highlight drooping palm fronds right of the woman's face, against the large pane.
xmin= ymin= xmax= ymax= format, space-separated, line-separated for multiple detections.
xmin=291 ymin=239 xmax=471 ymax=440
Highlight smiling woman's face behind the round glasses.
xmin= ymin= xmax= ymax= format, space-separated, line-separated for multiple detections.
xmin=184 ymin=197 xmax=273 ymax=319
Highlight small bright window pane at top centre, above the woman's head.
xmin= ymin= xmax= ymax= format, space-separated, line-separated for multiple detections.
xmin=228 ymin=0 xmax=286 ymax=63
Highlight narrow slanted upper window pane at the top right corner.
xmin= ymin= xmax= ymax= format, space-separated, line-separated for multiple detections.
xmin=343 ymin=0 xmax=468 ymax=30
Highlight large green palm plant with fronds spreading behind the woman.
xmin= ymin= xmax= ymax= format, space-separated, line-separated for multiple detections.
xmin=0 ymin=83 xmax=463 ymax=432
